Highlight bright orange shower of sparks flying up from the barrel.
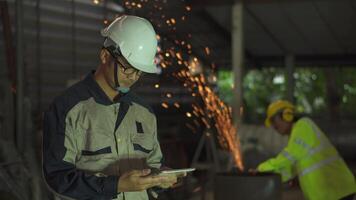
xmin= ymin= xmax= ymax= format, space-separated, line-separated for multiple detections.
xmin=119 ymin=0 xmax=243 ymax=170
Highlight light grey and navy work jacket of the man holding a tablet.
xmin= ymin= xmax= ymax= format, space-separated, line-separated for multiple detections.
xmin=43 ymin=73 xmax=162 ymax=200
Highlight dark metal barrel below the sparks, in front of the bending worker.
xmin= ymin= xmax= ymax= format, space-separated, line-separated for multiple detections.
xmin=214 ymin=173 xmax=282 ymax=200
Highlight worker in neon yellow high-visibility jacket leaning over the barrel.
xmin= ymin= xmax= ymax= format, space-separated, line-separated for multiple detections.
xmin=257 ymin=100 xmax=356 ymax=200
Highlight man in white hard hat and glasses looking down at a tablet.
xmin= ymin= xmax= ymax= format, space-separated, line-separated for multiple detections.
xmin=43 ymin=15 xmax=177 ymax=200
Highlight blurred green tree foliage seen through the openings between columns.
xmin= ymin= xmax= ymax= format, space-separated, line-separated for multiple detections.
xmin=218 ymin=67 xmax=356 ymax=123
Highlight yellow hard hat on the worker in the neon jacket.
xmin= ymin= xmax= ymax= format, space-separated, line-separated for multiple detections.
xmin=265 ymin=100 xmax=295 ymax=127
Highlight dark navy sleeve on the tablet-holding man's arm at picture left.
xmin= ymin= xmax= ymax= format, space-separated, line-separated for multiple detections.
xmin=43 ymin=103 xmax=118 ymax=200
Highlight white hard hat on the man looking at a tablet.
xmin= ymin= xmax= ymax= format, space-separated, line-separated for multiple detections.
xmin=101 ymin=15 xmax=157 ymax=73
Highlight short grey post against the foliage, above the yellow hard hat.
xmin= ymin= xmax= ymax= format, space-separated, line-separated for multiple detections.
xmin=285 ymin=54 xmax=295 ymax=103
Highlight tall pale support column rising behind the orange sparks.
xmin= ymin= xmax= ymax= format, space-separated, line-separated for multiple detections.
xmin=231 ymin=1 xmax=244 ymax=127
